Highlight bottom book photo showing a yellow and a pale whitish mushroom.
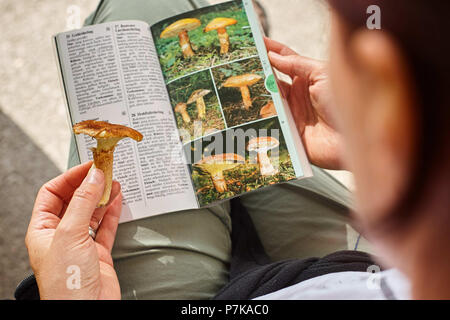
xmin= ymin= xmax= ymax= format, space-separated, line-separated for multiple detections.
xmin=184 ymin=117 xmax=295 ymax=205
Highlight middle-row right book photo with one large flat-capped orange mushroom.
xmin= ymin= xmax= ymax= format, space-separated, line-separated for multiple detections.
xmin=211 ymin=58 xmax=277 ymax=127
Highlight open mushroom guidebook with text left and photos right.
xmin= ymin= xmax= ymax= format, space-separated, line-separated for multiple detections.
xmin=54 ymin=0 xmax=312 ymax=222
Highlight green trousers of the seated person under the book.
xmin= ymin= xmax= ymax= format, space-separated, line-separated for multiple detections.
xmin=69 ymin=0 xmax=354 ymax=299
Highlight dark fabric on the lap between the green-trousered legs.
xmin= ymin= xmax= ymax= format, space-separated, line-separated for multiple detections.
xmin=213 ymin=199 xmax=375 ymax=300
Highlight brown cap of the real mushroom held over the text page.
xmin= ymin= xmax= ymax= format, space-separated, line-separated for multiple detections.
xmin=73 ymin=120 xmax=143 ymax=141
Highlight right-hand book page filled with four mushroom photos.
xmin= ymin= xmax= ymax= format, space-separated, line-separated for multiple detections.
xmin=151 ymin=0 xmax=311 ymax=206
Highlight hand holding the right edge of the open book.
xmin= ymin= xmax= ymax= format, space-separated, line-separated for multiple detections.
xmin=264 ymin=38 xmax=342 ymax=170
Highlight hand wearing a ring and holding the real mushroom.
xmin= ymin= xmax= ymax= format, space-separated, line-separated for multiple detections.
xmin=25 ymin=162 xmax=122 ymax=299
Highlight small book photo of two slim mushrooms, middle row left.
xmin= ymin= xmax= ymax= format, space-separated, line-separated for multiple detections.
xmin=167 ymin=70 xmax=225 ymax=142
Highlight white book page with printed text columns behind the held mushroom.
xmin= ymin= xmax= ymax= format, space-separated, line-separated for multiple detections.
xmin=56 ymin=21 xmax=198 ymax=222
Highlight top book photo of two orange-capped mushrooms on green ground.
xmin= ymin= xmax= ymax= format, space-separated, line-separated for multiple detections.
xmin=151 ymin=0 xmax=258 ymax=82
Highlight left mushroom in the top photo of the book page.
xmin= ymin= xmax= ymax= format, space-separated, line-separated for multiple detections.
xmin=160 ymin=18 xmax=202 ymax=58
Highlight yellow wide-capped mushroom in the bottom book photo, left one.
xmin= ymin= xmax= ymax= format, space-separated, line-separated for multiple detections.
xmin=194 ymin=153 xmax=245 ymax=193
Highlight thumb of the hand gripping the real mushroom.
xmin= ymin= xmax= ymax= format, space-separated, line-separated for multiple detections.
xmin=59 ymin=168 xmax=105 ymax=233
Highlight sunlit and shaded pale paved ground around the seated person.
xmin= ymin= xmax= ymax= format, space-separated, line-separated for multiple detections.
xmin=0 ymin=0 xmax=358 ymax=299
